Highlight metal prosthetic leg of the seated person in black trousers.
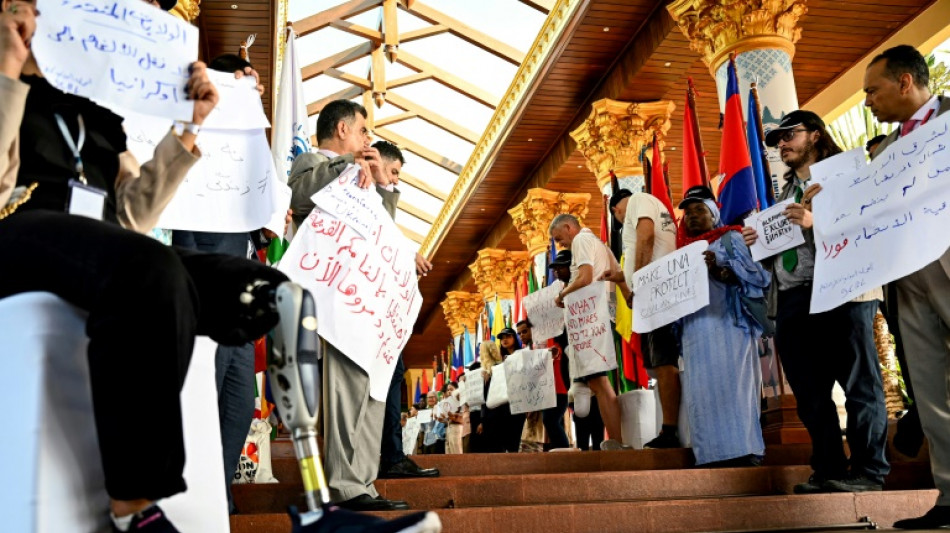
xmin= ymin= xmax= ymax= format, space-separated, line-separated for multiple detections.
xmin=267 ymin=282 xmax=330 ymax=511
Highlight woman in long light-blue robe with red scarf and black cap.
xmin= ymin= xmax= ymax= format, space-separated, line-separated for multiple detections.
xmin=677 ymin=190 xmax=770 ymax=466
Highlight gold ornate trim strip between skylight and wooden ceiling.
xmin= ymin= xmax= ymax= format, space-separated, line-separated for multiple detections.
xmin=419 ymin=0 xmax=582 ymax=258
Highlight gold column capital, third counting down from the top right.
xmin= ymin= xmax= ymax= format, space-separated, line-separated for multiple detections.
xmin=508 ymin=188 xmax=590 ymax=257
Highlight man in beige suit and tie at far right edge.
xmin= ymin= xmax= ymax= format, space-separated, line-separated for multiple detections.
xmin=864 ymin=45 xmax=950 ymax=529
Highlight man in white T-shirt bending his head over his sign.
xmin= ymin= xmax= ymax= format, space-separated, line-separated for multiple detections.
xmin=548 ymin=213 xmax=621 ymax=450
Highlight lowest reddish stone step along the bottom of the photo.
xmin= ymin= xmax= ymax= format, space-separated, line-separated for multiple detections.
xmin=231 ymin=488 xmax=937 ymax=533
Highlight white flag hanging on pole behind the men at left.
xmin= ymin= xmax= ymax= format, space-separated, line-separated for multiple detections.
xmin=267 ymin=25 xmax=311 ymax=264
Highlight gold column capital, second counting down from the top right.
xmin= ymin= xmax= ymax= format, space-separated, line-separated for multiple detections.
xmin=571 ymin=98 xmax=676 ymax=190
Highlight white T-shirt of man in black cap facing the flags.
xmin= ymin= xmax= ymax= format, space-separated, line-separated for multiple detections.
xmin=623 ymin=192 xmax=676 ymax=287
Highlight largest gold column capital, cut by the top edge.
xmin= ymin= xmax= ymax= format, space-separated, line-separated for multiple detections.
xmin=666 ymin=0 xmax=808 ymax=76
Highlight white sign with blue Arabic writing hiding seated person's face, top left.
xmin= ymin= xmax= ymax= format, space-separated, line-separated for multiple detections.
xmin=31 ymin=0 xmax=198 ymax=121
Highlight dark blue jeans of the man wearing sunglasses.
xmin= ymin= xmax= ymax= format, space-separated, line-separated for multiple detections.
xmin=775 ymin=286 xmax=890 ymax=482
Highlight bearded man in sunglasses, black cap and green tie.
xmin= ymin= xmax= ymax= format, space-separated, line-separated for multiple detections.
xmin=742 ymin=110 xmax=890 ymax=494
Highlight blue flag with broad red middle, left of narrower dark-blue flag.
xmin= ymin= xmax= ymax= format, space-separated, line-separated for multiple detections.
xmin=719 ymin=57 xmax=758 ymax=226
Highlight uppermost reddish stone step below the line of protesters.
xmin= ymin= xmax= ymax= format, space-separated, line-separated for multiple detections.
xmin=271 ymin=440 xmax=811 ymax=482
